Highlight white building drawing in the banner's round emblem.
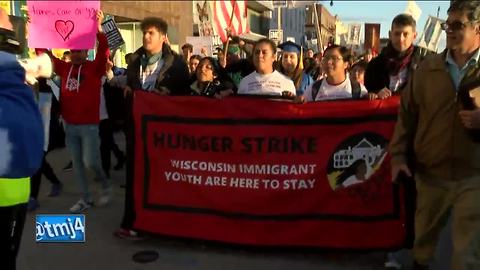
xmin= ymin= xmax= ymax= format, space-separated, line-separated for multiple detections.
xmin=333 ymin=138 xmax=384 ymax=169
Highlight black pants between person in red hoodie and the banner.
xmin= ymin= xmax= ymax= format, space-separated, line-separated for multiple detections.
xmin=99 ymin=119 xmax=123 ymax=177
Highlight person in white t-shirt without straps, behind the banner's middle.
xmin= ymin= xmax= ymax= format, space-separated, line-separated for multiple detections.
xmin=238 ymin=38 xmax=296 ymax=97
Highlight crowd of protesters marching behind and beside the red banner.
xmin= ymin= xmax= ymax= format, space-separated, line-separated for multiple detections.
xmin=2 ymin=1 xmax=480 ymax=269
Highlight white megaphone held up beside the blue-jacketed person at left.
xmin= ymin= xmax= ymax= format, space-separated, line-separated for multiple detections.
xmin=18 ymin=53 xmax=53 ymax=85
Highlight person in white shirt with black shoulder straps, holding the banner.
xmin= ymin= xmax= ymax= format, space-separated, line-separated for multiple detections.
xmin=297 ymin=45 xmax=368 ymax=103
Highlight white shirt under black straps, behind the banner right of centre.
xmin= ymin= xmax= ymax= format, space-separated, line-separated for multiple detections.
xmin=303 ymin=76 xmax=368 ymax=102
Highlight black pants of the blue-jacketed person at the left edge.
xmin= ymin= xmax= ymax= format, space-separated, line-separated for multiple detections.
xmin=0 ymin=202 xmax=27 ymax=270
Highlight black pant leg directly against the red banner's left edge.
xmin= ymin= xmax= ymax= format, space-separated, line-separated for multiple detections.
xmin=120 ymin=95 xmax=135 ymax=229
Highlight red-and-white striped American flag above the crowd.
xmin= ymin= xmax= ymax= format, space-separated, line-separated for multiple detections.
xmin=213 ymin=0 xmax=250 ymax=42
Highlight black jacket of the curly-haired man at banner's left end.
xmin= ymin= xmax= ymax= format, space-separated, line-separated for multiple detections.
xmin=127 ymin=44 xmax=190 ymax=95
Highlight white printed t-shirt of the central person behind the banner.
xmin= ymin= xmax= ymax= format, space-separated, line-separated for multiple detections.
xmin=238 ymin=70 xmax=296 ymax=96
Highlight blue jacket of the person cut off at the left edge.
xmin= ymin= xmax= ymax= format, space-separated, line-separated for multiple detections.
xmin=0 ymin=51 xmax=43 ymax=178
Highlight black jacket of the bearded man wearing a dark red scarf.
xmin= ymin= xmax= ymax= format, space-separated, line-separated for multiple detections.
xmin=365 ymin=46 xmax=430 ymax=93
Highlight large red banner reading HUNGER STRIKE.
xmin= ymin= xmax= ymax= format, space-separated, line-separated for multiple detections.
xmin=134 ymin=91 xmax=406 ymax=248
